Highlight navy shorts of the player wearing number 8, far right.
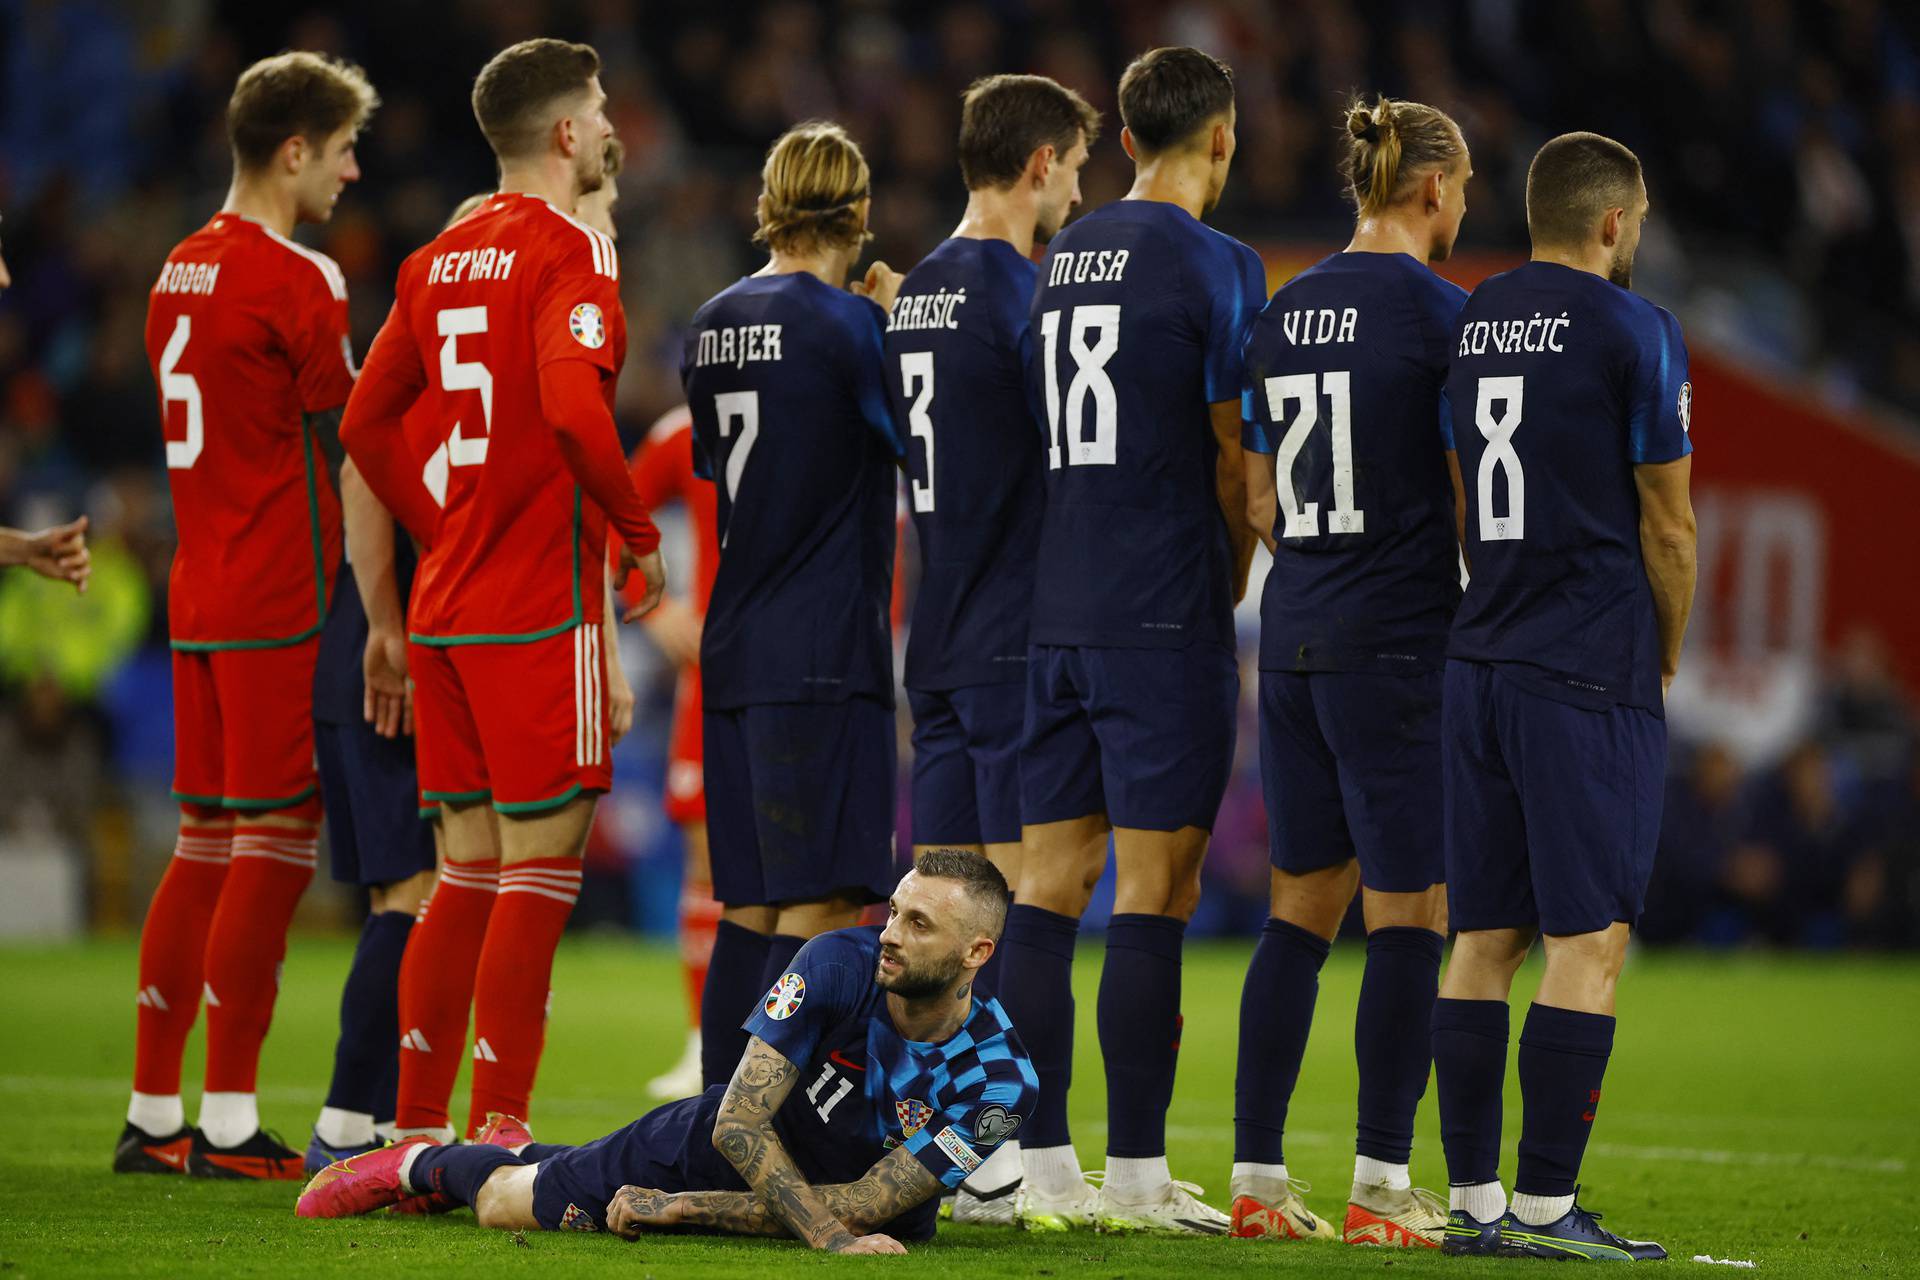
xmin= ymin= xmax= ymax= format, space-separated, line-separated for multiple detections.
xmin=1440 ymin=660 xmax=1667 ymax=936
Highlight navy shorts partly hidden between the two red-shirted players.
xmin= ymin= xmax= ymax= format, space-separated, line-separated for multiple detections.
xmin=313 ymin=722 xmax=434 ymax=885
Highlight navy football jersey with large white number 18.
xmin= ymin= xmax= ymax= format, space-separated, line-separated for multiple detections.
xmin=1029 ymin=200 xmax=1267 ymax=649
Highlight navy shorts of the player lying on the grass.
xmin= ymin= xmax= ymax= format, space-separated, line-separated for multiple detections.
xmin=528 ymin=1084 xmax=747 ymax=1232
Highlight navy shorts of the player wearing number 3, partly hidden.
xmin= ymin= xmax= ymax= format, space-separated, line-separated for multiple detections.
xmin=906 ymin=681 xmax=1027 ymax=844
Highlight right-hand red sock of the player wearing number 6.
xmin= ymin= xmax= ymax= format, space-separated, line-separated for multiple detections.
xmin=205 ymin=827 xmax=319 ymax=1094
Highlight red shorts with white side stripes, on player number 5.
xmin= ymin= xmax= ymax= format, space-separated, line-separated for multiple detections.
xmin=407 ymin=622 xmax=612 ymax=814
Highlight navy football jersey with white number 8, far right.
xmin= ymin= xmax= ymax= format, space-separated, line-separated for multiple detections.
xmin=1448 ymin=263 xmax=1693 ymax=714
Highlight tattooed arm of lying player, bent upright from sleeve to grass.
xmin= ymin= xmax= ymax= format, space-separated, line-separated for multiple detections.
xmin=714 ymin=1036 xmax=854 ymax=1251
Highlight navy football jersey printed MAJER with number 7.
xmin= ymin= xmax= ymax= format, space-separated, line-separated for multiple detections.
xmin=680 ymin=273 xmax=902 ymax=710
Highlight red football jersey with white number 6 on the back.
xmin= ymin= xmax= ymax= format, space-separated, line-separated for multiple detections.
xmin=146 ymin=213 xmax=353 ymax=649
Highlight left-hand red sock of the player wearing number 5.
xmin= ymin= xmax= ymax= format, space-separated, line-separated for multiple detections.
xmin=394 ymin=858 xmax=499 ymax=1128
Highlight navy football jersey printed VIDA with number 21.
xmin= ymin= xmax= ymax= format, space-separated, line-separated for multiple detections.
xmin=1240 ymin=253 xmax=1467 ymax=672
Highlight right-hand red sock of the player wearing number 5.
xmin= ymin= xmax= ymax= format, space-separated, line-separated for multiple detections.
xmin=467 ymin=858 xmax=580 ymax=1134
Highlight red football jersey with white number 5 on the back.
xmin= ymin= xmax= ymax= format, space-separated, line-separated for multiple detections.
xmin=365 ymin=192 xmax=626 ymax=643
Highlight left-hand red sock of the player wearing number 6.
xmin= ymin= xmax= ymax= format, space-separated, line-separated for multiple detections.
xmin=132 ymin=823 xmax=232 ymax=1096
